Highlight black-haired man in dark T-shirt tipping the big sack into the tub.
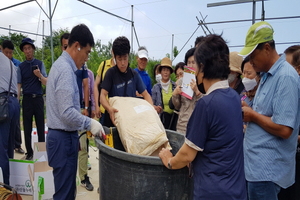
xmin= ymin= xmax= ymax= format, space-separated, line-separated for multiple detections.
xmin=100 ymin=36 xmax=153 ymax=127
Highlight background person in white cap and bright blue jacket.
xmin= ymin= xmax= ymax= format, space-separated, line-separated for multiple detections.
xmin=134 ymin=47 xmax=152 ymax=95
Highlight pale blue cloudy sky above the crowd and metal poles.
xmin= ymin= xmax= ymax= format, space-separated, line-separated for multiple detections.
xmin=0 ymin=0 xmax=300 ymax=65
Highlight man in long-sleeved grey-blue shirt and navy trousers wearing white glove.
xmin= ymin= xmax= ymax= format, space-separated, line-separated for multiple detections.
xmin=46 ymin=24 xmax=104 ymax=200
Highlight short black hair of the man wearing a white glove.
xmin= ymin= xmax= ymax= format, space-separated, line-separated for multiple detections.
xmin=68 ymin=24 xmax=95 ymax=47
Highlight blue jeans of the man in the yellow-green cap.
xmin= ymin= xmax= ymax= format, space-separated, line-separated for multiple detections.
xmin=247 ymin=181 xmax=280 ymax=200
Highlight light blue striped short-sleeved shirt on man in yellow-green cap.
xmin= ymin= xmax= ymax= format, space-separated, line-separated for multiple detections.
xmin=244 ymin=55 xmax=300 ymax=188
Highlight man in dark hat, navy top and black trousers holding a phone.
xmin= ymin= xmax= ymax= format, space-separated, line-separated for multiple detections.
xmin=18 ymin=38 xmax=47 ymax=160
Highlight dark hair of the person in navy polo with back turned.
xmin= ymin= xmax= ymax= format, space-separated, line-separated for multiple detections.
xmin=194 ymin=34 xmax=230 ymax=80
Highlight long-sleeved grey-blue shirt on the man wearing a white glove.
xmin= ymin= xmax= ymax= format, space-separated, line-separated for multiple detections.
xmin=46 ymin=51 xmax=91 ymax=131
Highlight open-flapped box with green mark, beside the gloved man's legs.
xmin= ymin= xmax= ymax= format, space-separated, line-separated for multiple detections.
xmin=28 ymin=161 xmax=55 ymax=200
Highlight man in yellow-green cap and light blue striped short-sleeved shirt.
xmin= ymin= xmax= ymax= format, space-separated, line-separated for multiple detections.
xmin=240 ymin=21 xmax=300 ymax=200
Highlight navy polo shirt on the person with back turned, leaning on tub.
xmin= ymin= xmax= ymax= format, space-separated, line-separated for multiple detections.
xmin=186 ymin=80 xmax=247 ymax=200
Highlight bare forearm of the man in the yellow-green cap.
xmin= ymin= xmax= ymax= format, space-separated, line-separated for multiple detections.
xmin=242 ymin=101 xmax=293 ymax=139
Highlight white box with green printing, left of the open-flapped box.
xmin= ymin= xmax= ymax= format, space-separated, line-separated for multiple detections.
xmin=9 ymin=159 xmax=34 ymax=195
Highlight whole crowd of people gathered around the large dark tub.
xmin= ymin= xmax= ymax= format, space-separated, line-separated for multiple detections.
xmin=0 ymin=21 xmax=300 ymax=200
